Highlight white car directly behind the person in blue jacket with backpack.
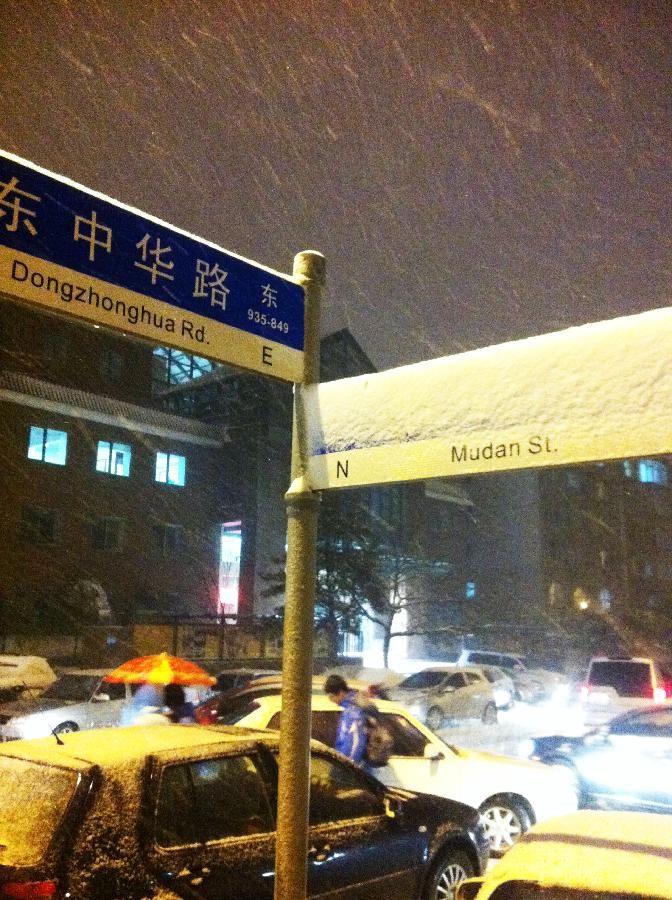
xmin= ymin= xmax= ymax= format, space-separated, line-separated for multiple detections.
xmin=226 ymin=694 xmax=577 ymax=853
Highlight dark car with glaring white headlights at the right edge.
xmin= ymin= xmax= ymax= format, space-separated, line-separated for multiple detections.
xmin=530 ymin=704 xmax=672 ymax=813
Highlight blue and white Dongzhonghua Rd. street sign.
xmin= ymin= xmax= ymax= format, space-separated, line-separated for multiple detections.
xmin=0 ymin=151 xmax=304 ymax=381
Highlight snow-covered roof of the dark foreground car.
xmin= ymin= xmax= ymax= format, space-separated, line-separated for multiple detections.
xmin=0 ymin=725 xmax=272 ymax=767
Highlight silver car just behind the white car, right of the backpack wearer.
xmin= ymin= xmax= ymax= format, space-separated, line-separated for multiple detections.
xmin=387 ymin=665 xmax=512 ymax=731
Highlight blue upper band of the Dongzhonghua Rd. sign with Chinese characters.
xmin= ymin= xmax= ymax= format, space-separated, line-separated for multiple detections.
xmin=0 ymin=151 xmax=304 ymax=351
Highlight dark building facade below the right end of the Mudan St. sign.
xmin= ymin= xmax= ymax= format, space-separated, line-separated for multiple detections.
xmin=541 ymin=457 xmax=672 ymax=613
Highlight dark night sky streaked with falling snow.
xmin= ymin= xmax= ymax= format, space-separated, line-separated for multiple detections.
xmin=0 ymin=0 xmax=672 ymax=368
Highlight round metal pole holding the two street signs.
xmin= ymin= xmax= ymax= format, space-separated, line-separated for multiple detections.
xmin=275 ymin=250 xmax=325 ymax=900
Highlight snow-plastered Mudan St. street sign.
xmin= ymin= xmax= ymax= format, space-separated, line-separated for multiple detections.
xmin=301 ymin=308 xmax=672 ymax=490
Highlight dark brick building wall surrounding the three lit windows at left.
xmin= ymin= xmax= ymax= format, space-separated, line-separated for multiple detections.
xmin=0 ymin=403 xmax=222 ymax=621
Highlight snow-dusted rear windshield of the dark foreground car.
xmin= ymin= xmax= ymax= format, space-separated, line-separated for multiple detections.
xmin=0 ymin=756 xmax=78 ymax=866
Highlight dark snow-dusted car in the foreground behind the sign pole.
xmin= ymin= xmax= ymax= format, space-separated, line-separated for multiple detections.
xmin=0 ymin=725 xmax=488 ymax=900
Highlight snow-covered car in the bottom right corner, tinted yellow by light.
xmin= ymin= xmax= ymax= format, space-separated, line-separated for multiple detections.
xmin=457 ymin=810 xmax=672 ymax=900
